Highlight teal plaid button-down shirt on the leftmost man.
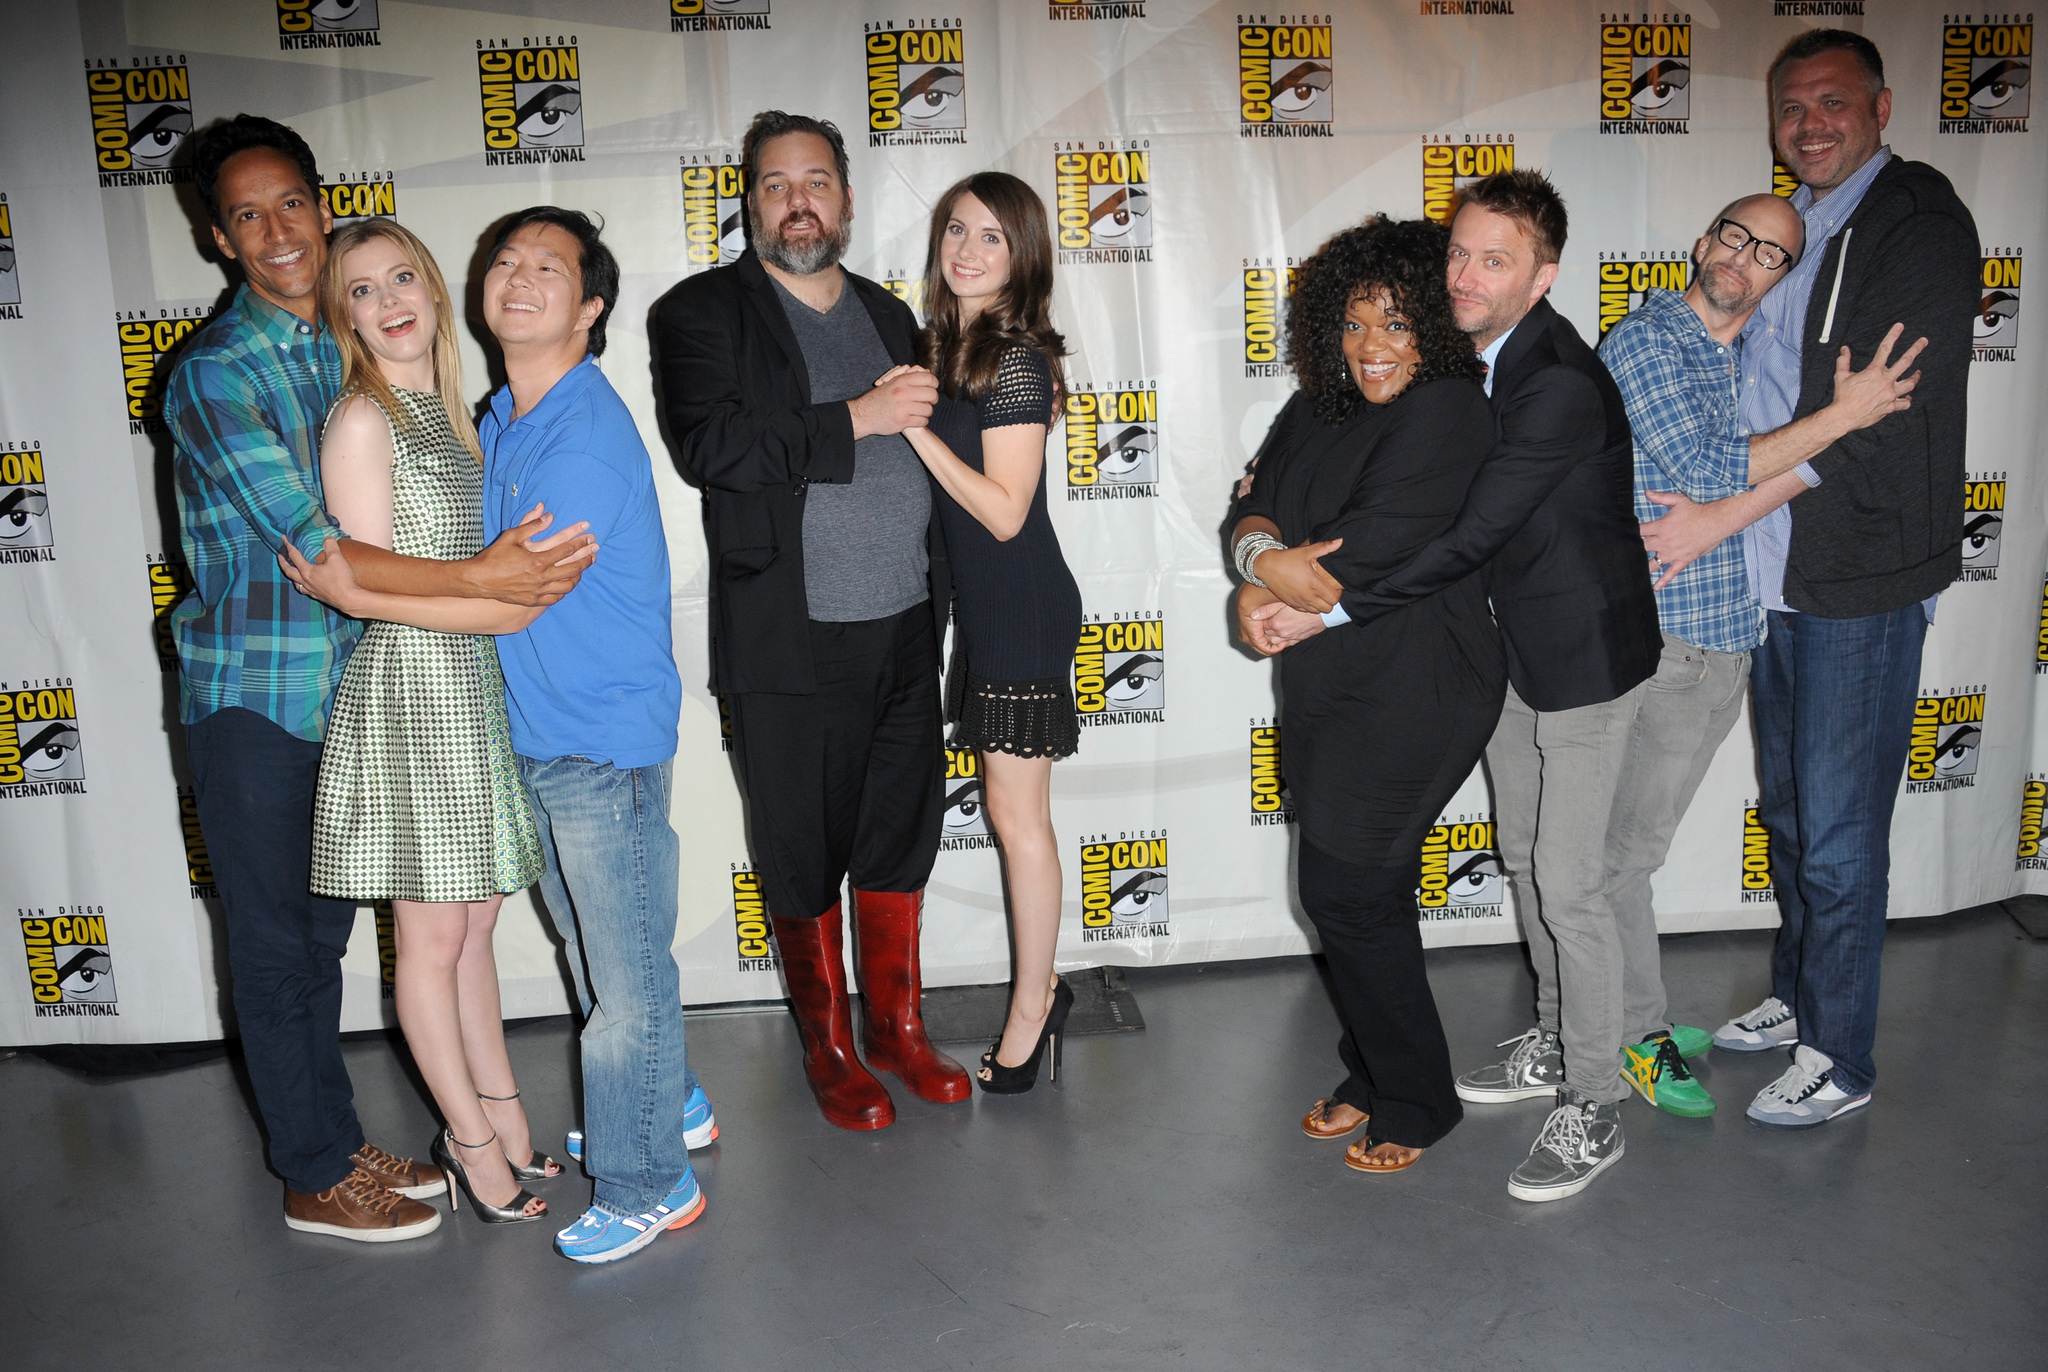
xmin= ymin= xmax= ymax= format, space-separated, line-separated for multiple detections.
xmin=164 ymin=285 xmax=360 ymax=741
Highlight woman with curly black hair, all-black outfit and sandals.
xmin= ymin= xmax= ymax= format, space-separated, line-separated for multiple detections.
xmin=1231 ymin=215 xmax=1507 ymax=1171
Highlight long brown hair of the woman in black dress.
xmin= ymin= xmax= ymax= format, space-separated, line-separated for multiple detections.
xmin=922 ymin=172 xmax=1067 ymax=411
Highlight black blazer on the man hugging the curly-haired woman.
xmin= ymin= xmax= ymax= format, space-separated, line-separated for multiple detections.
xmin=1343 ymin=299 xmax=1663 ymax=711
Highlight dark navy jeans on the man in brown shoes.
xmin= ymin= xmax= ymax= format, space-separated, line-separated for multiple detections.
xmin=184 ymin=709 xmax=362 ymax=1192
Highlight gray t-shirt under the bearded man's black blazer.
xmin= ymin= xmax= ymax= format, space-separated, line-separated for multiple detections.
xmin=770 ymin=276 xmax=932 ymax=623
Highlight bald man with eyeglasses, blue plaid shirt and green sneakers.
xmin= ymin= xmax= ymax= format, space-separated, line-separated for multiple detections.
xmin=1599 ymin=195 xmax=1919 ymax=1154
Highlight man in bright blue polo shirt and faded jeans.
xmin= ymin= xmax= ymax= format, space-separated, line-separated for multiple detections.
xmin=477 ymin=205 xmax=709 ymax=1263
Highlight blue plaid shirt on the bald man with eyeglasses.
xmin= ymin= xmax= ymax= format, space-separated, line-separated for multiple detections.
xmin=1599 ymin=291 xmax=1763 ymax=653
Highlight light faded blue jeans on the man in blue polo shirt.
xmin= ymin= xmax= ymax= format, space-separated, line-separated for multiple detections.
xmin=518 ymin=758 xmax=696 ymax=1214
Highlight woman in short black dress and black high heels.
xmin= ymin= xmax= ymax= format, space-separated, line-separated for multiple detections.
xmin=901 ymin=172 xmax=1081 ymax=1094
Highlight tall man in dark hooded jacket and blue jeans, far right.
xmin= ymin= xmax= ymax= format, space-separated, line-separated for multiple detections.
xmin=1622 ymin=29 xmax=1980 ymax=1128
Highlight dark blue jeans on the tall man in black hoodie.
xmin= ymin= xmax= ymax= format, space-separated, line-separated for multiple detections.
xmin=1749 ymin=604 xmax=1927 ymax=1096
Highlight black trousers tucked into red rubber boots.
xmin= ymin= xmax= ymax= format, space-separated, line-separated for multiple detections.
xmin=727 ymin=602 xmax=946 ymax=919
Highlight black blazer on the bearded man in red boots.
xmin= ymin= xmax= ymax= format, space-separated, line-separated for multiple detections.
xmin=653 ymin=250 xmax=952 ymax=696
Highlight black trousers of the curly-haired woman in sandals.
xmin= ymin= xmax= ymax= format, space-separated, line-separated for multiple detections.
xmin=1296 ymin=840 xmax=1464 ymax=1149
